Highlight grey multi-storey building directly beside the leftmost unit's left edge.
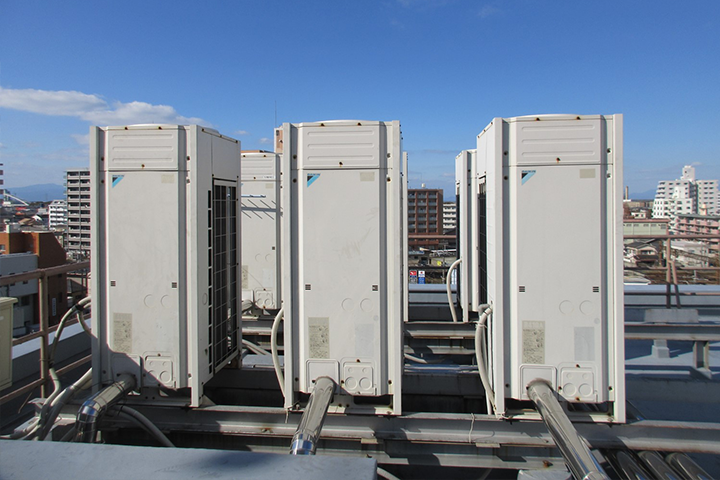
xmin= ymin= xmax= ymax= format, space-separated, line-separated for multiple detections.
xmin=65 ymin=168 xmax=90 ymax=258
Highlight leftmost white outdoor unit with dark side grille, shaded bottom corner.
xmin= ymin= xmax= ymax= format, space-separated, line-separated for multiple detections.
xmin=90 ymin=125 xmax=242 ymax=406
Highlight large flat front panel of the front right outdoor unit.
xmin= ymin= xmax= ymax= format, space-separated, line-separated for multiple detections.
xmin=506 ymin=165 xmax=607 ymax=403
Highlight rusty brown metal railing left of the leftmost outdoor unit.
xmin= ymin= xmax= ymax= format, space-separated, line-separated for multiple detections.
xmin=0 ymin=261 xmax=90 ymax=405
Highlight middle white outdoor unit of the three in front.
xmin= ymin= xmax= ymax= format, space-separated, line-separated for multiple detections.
xmin=281 ymin=120 xmax=407 ymax=414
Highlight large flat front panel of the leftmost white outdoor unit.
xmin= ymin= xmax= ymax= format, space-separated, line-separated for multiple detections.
xmin=103 ymin=171 xmax=185 ymax=388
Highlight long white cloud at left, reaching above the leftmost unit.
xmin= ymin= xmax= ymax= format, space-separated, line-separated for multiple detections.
xmin=0 ymin=87 xmax=210 ymax=125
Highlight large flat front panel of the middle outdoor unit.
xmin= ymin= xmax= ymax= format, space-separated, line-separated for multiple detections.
xmin=298 ymin=169 xmax=386 ymax=395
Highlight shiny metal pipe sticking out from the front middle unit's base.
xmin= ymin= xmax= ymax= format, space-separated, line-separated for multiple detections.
xmin=290 ymin=377 xmax=336 ymax=455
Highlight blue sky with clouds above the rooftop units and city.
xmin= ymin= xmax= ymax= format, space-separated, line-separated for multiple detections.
xmin=0 ymin=0 xmax=720 ymax=196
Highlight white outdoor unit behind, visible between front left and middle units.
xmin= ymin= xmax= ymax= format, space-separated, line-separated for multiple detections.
xmin=241 ymin=152 xmax=281 ymax=310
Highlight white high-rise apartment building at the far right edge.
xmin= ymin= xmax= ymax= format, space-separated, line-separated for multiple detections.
xmin=653 ymin=165 xmax=720 ymax=232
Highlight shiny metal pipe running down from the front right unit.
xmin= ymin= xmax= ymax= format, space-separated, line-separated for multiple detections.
xmin=528 ymin=379 xmax=609 ymax=480
